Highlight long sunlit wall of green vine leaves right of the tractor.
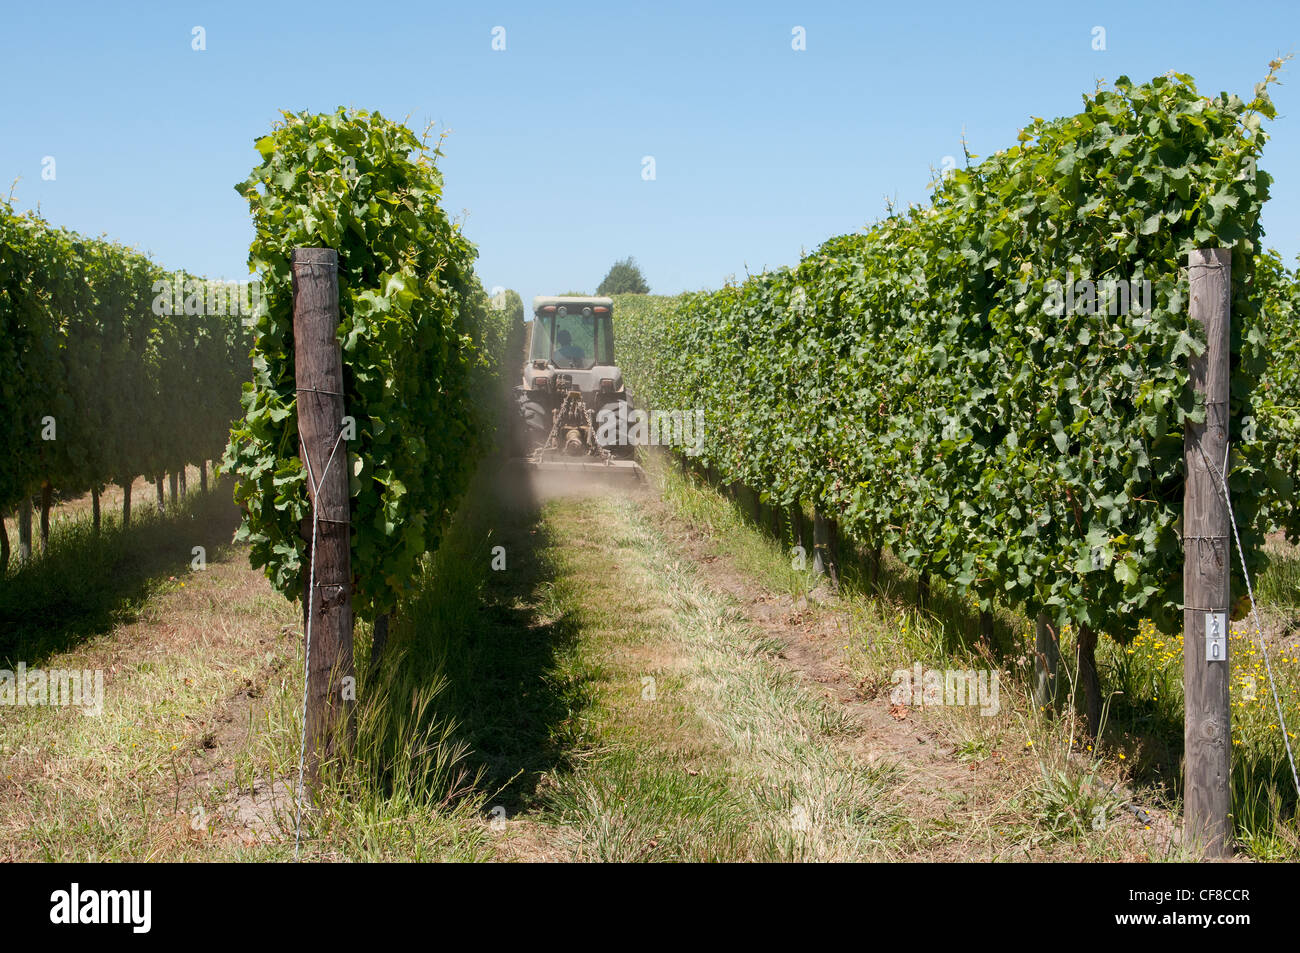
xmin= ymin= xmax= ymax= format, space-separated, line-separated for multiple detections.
xmin=615 ymin=74 xmax=1282 ymax=637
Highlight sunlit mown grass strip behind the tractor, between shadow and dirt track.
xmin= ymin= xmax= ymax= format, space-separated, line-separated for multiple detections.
xmin=533 ymin=498 xmax=893 ymax=861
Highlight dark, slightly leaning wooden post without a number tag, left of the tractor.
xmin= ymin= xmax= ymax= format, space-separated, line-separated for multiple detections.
xmin=293 ymin=248 xmax=356 ymax=780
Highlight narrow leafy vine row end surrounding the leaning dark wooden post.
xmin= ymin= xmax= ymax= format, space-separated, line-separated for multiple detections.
xmin=222 ymin=109 xmax=523 ymax=619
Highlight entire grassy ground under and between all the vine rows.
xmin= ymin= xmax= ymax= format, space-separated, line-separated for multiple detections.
xmin=0 ymin=447 xmax=1300 ymax=861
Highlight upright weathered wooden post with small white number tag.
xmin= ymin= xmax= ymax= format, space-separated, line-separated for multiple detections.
xmin=1183 ymin=248 xmax=1232 ymax=857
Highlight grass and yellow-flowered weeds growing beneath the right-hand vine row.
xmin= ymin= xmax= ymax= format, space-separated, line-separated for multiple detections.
xmin=658 ymin=452 xmax=1300 ymax=861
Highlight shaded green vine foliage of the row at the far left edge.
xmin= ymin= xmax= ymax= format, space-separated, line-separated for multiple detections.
xmin=0 ymin=203 xmax=247 ymax=527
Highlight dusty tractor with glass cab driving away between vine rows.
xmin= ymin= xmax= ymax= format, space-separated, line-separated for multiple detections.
xmin=515 ymin=296 xmax=645 ymax=482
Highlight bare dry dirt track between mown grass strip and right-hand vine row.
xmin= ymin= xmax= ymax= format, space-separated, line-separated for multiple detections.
xmin=624 ymin=470 xmax=1173 ymax=861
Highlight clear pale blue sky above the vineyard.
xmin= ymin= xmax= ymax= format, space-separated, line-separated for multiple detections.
xmin=0 ymin=0 xmax=1300 ymax=299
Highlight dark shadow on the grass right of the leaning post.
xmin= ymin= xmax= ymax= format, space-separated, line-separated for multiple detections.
xmin=359 ymin=459 xmax=595 ymax=815
